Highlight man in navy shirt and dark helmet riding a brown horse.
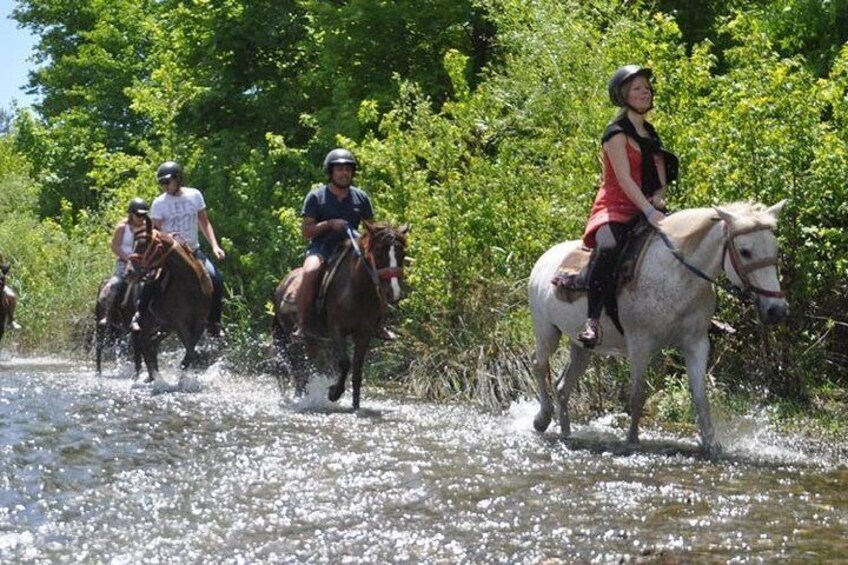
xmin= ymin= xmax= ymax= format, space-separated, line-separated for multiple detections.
xmin=293 ymin=149 xmax=395 ymax=340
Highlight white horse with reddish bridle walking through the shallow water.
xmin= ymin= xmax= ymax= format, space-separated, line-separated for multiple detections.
xmin=529 ymin=200 xmax=788 ymax=457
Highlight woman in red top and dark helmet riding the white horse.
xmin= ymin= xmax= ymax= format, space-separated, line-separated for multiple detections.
xmin=577 ymin=65 xmax=677 ymax=348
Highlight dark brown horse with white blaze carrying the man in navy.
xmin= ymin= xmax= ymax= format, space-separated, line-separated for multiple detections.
xmin=274 ymin=219 xmax=408 ymax=410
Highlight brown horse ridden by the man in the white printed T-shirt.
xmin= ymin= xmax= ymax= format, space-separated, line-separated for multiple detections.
xmin=132 ymin=216 xmax=212 ymax=382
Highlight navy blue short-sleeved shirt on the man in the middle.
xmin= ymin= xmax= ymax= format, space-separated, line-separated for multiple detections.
xmin=300 ymin=185 xmax=374 ymax=258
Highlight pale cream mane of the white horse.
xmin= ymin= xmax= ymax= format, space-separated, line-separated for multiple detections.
xmin=662 ymin=202 xmax=775 ymax=255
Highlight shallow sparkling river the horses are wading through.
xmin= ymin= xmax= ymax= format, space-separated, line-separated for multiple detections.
xmin=0 ymin=357 xmax=848 ymax=564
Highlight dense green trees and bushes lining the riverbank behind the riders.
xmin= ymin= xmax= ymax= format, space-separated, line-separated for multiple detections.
xmin=0 ymin=0 xmax=848 ymax=428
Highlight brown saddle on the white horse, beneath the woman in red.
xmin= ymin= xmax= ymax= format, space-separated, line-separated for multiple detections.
xmin=551 ymin=218 xmax=655 ymax=304
